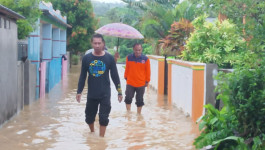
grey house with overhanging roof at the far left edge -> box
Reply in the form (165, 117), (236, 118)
(0, 4), (24, 125)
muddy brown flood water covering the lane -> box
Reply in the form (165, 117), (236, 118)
(0, 65), (198, 150)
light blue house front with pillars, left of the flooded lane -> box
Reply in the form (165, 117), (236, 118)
(28, 2), (69, 99)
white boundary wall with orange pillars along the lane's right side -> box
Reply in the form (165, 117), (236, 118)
(148, 55), (222, 122)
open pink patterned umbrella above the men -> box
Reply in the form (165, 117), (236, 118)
(95, 23), (144, 51)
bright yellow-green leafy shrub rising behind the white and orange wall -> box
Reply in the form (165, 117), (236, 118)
(183, 16), (246, 68)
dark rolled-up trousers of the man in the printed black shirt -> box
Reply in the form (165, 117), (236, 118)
(85, 96), (111, 126)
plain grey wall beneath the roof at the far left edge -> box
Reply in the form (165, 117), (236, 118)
(0, 15), (18, 124)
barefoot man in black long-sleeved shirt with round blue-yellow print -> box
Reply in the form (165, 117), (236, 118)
(76, 34), (122, 137)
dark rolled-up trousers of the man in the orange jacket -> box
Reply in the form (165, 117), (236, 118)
(124, 84), (145, 107)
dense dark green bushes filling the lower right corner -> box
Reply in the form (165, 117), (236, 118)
(194, 58), (265, 150)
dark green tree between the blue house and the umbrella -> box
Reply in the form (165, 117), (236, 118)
(50, 0), (97, 54)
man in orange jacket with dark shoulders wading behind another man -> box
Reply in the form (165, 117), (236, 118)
(124, 43), (150, 114)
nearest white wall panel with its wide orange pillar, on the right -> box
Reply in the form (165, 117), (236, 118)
(167, 59), (207, 122)
